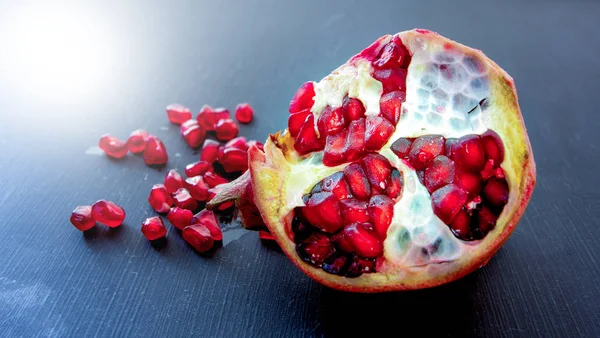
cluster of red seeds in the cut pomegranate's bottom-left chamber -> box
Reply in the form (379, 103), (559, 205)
(292, 154), (403, 277)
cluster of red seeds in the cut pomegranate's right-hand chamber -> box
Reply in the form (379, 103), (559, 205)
(392, 130), (509, 240)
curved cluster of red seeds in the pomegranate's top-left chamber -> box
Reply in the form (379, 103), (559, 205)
(288, 36), (410, 166)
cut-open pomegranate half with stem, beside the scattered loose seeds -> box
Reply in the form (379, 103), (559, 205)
(207, 30), (535, 292)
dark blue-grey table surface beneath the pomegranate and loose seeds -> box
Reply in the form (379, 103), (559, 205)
(0, 0), (600, 337)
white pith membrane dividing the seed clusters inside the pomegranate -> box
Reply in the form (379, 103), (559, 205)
(281, 35), (504, 273)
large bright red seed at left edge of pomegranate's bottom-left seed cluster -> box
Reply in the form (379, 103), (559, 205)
(303, 191), (343, 233)
